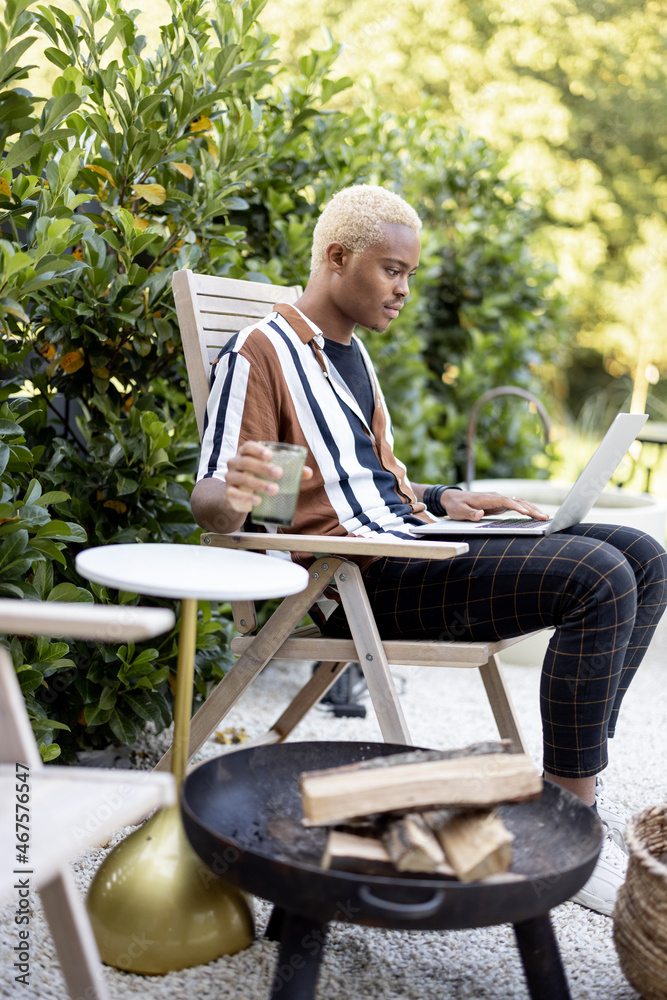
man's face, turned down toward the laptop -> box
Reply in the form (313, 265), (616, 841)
(335, 223), (421, 333)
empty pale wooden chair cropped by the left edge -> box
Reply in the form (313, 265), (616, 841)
(0, 599), (176, 1000)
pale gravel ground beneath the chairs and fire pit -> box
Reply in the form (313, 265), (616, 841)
(0, 624), (667, 1000)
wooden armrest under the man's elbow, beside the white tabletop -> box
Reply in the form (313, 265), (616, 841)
(201, 531), (468, 559)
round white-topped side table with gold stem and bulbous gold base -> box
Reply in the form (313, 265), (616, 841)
(76, 542), (308, 975)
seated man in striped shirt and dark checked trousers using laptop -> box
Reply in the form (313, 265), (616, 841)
(192, 185), (667, 914)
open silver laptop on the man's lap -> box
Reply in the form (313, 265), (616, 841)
(410, 413), (648, 537)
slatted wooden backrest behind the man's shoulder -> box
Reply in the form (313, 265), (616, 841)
(173, 270), (301, 437)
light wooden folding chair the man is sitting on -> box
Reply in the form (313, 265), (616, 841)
(158, 270), (548, 768)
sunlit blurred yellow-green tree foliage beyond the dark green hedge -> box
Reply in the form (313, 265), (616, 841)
(264, 0), (667, 422)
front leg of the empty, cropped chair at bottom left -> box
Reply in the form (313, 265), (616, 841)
(39, 868), (109, 1000)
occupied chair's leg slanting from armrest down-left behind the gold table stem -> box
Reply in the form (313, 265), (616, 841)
(155, 556), (342, 771)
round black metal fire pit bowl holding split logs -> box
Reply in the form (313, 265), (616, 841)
(181, 742), (602, 930)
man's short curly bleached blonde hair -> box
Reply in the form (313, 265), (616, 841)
(310, 184), (422, 277)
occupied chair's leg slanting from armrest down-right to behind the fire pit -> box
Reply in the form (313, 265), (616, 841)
(334, 562), (412, 746)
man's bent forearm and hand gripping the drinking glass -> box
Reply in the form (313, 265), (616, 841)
(190, 441), (313, 534)
